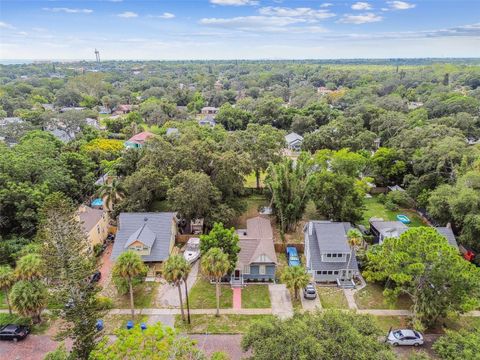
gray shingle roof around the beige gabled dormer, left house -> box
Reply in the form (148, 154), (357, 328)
(112, 212), (175, 262)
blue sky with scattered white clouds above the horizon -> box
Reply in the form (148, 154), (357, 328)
(0, 0), (480, 60)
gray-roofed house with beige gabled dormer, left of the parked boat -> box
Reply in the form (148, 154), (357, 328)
(112, 212), (177, 273)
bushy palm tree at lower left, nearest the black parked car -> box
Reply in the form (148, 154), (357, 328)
(10, 280), (48, 323)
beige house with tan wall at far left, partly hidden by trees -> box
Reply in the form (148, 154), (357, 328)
(77, 205), (109, 249)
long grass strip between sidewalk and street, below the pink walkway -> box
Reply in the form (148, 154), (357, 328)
(175, 312), (272, 334)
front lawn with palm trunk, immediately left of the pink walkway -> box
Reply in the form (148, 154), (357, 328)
(188, 277), (233, 309)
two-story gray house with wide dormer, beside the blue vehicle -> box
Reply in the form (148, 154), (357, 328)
(304, 221), (359, 287)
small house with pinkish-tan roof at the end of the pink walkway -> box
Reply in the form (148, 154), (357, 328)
(230, 216), (278, 286)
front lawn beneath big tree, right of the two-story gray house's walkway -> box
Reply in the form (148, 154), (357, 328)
(355, 283), (412, 310)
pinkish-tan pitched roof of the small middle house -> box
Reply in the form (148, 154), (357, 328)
(237, 216), (277, 268)
